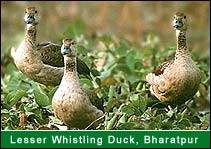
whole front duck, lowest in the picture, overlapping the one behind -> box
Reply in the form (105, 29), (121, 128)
(52, 38), (104, 129)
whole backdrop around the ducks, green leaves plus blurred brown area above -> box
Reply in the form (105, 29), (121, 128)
(1, 1), (210, 130)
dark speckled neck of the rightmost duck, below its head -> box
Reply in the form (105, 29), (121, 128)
(175, 30), (188, 59)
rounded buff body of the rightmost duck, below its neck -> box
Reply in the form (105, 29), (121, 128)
(147, 53), (200, 104)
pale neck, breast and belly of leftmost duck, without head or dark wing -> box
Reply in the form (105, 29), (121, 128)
(12, 22), (64, 86)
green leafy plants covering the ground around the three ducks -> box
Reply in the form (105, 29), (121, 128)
(1, 21), (210, 130)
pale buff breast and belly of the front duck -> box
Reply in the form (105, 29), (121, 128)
(52, 73), (103, 129)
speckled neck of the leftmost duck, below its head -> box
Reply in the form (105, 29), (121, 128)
(25, 24), (37, 47)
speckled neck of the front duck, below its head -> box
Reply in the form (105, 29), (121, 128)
(64, 56), (78, 79)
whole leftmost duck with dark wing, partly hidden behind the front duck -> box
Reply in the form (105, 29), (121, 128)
(11, 7), (90, 86)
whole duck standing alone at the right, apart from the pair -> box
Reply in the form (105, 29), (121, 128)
(146, 12), (201, 105)
